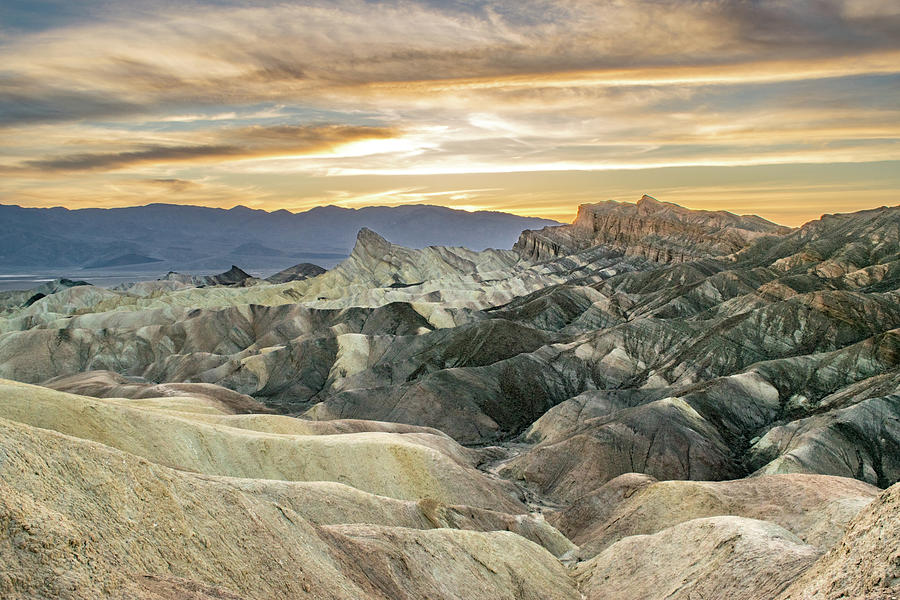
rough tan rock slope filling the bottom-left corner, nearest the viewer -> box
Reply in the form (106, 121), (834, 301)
(0, 419), (579, 600)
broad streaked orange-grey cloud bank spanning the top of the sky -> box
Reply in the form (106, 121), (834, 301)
(2, 0), (900, 119)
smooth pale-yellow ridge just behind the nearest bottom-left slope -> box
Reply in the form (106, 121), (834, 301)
(0, 382), (522, 512)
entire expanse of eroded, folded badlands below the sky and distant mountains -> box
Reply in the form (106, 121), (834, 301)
(0, 197), (900, 600)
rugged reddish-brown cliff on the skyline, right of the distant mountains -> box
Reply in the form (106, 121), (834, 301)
(514, 196), (791, 264)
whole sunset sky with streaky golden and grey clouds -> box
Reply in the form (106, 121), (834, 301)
(0, 0), (900, 226)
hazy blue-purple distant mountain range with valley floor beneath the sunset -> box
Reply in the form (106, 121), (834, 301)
(0, 204), (557, 272)
